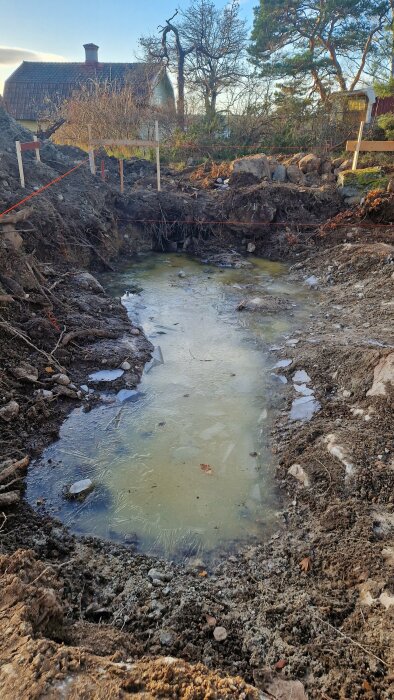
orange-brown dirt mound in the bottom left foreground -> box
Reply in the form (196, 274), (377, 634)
(0, 550), (261, 700)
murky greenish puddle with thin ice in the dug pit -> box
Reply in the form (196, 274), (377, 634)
(27, 255), (302, 558)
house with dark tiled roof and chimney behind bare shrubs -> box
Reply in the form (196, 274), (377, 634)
(4, 44), (175, 132)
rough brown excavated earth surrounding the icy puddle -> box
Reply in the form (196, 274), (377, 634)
(0, 106), (394, 700)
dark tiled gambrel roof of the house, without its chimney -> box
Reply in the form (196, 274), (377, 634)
(3, 61), (164, 120)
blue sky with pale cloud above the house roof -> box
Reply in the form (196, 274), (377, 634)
(0, 0), (258, 94)
